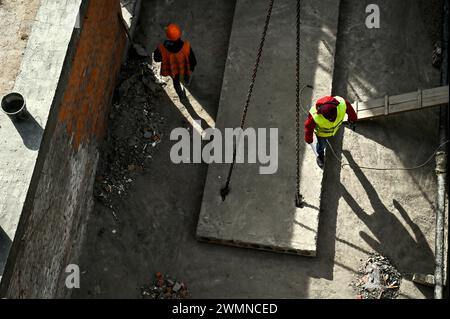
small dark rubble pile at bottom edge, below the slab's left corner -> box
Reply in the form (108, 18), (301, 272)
(141, 272), (189, 299)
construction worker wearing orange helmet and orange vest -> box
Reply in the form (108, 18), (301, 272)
(153, 23), (197, 99)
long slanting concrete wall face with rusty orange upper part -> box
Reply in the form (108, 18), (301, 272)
(0, 0), (126, 298)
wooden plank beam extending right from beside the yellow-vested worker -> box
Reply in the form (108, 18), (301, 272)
(355, 86), (449, 120)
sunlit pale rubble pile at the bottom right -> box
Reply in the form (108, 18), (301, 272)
(352, 255), (402, 299)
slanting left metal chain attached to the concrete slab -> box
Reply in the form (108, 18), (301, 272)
(220, 0), (275, 200)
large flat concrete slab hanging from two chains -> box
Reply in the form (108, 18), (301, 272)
(197, 0), (340, 256)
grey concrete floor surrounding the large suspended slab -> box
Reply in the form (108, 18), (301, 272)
(74, 0), (440, 298)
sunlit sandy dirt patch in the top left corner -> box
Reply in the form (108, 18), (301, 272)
(0, 0), (41, 97)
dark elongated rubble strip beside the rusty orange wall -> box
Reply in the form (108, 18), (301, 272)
(94, 59), (164, 208)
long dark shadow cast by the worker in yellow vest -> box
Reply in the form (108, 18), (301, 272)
(342, 151), (434, 284)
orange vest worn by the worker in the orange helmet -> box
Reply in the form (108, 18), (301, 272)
(158, 41), (191, 78)
